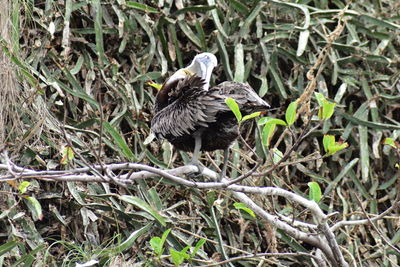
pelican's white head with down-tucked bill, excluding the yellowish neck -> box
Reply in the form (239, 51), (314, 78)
(184, 53), (218, 90)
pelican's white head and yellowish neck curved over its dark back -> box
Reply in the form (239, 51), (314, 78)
(165, 53), (218, 90)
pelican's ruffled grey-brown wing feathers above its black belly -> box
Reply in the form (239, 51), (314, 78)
(151, 81), (269, 139)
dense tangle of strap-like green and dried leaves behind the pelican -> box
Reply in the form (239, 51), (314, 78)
(0, 0), (400, 266)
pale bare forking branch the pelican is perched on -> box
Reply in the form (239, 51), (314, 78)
(0, 151), (348, 266)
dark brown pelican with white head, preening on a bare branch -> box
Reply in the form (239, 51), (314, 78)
(151, 53), (270, 178)
